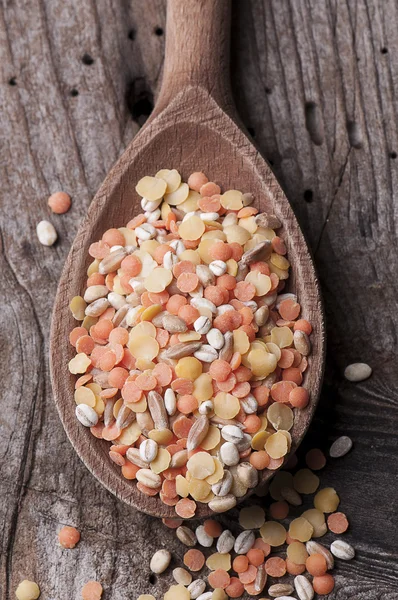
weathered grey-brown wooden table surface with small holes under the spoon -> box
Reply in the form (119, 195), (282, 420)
(0, 0), (398, 600)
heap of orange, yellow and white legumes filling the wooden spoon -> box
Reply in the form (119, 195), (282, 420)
(69, 169), (312, 518)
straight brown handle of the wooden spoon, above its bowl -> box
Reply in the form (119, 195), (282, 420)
(156, 0), (232, 112)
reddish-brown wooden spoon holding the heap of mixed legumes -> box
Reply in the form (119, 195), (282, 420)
(51, 0), (325, 517)
